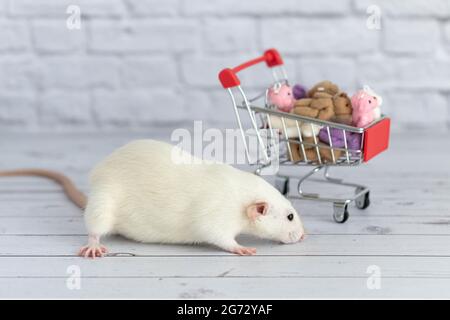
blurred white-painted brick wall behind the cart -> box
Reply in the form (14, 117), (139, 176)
(0, 0), (450, 132)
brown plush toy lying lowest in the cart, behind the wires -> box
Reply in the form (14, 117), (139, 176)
(290, 137), (342, 163)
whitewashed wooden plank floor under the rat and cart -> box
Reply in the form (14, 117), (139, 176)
(0, 134), (450, 299)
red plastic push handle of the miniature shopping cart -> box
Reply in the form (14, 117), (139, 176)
(219, 49), (283, 89)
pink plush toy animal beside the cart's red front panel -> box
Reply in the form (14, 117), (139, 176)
(351, 90), (379, 128)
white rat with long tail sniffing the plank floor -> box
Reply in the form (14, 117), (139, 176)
(0, 140), (304, 258)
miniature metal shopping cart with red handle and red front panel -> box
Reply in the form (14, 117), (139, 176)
(219, 49), (390, 223)
